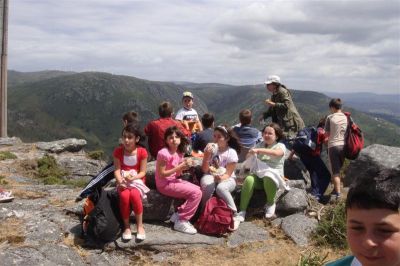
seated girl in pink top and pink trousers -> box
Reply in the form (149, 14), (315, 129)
(156, 126), (201, 234)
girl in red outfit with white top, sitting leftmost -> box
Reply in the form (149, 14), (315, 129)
(113, 124), (149, 241)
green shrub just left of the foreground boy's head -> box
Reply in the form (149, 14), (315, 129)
(312, 201), (347, 249)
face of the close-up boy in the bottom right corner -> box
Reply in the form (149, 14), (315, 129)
(346, 208), (400, 266)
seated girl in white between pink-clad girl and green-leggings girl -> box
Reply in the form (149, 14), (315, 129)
(200, 125), (241, 229)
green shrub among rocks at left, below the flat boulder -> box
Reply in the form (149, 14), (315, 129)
(37, 154), (68, 185)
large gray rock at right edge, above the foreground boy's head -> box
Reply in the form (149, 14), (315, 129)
(343, 144), (400, 186)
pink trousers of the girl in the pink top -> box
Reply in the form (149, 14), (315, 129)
(157, 179), (202, 221)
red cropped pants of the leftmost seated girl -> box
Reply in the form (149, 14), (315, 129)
(118, 188), (143, 219)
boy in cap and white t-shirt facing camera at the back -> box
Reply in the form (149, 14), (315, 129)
(175, 91), (203, 134)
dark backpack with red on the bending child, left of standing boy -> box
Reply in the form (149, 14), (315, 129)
(293, 127), (323, 156)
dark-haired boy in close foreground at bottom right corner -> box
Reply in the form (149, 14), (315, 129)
(327, 169), (400, 266)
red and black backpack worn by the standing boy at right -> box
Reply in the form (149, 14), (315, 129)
(344, 112), (364, 160)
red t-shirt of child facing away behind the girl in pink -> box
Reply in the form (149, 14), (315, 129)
(144, 117), (187, 158)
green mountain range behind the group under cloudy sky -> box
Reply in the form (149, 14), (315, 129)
(8, 71), (400, 154)
